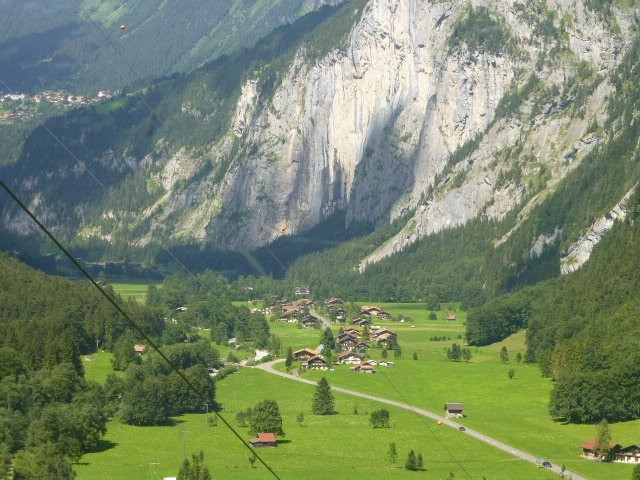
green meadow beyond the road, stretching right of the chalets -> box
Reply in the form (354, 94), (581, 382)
(286, 303), (640, 480)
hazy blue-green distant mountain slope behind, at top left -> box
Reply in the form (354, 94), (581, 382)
(0, 0), (339, 93)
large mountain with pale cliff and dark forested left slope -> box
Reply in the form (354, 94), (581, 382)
(2, 0), (637, 284)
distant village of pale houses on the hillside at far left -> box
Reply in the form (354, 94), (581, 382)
(0, 90), (115, 123)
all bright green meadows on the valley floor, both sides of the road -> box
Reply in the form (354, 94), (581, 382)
(76, 302), (640, 480)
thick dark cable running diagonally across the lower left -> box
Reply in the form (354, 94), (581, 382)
(0, 179), (282, 480)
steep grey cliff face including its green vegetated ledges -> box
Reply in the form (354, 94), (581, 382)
(5, 0), (634, 264)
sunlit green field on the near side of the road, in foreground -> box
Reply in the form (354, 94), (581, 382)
(75, 369), (554, 480)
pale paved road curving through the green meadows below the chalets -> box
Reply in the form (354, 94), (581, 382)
(255, 359), (587, 480)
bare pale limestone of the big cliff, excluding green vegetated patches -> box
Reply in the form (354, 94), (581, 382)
(178, 0), (628, 253)
